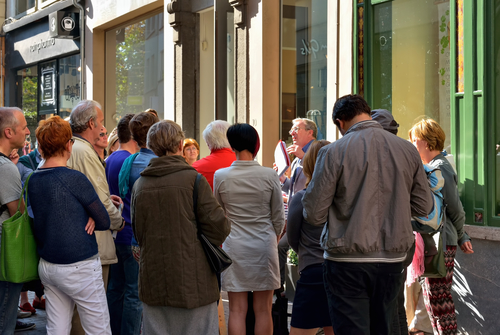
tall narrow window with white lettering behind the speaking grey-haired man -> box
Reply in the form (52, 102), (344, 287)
(281, 0), (327, 143)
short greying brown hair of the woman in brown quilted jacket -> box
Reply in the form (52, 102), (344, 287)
(147, 120), (184, 157)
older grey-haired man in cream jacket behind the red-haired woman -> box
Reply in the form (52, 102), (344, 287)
(68, 100), (124, 334)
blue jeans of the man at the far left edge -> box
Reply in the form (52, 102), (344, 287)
(0, 281), (23, 335)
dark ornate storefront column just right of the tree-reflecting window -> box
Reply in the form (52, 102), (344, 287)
(167, 0), (198, 138)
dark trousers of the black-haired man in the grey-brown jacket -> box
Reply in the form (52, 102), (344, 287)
(323, 260), (404, 335)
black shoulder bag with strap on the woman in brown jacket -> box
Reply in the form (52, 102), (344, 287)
(193, 173), (233, 273)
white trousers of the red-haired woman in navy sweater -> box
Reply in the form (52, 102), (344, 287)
(38, 257), (111, 335)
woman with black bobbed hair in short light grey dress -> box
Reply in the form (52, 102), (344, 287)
(214, 124), (285, 335)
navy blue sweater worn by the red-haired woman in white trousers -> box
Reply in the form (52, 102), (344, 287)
(28, 167), (110, 264)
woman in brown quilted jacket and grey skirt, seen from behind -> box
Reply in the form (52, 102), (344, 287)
(131, 120), (230, 334)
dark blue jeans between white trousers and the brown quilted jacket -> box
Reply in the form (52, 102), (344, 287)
(107, 244), (142, 335)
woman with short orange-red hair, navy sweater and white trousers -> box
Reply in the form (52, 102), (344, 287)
(27, 116), (111, 334)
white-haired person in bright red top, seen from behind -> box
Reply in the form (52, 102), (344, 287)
(192, 120), (236, 189)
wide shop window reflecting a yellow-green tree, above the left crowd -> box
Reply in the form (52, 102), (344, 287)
(105, 13), (164, 127)
